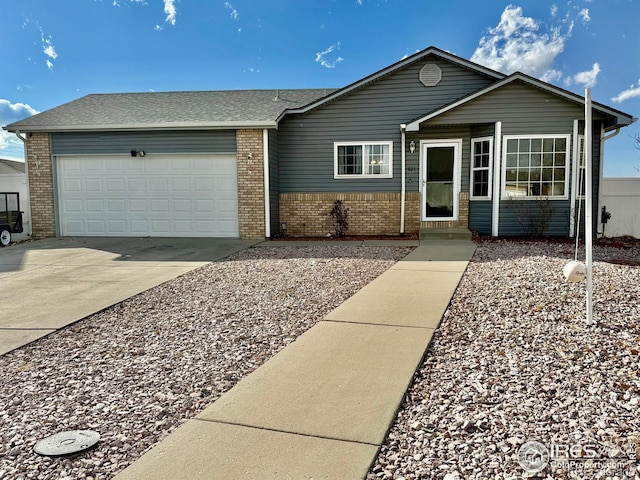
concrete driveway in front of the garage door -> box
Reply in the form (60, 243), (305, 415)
(0, 238), (259, 355)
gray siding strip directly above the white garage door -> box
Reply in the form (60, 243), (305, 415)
(51, 130), (236, 155)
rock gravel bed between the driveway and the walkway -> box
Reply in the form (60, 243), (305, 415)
(0, 245), (411, 480)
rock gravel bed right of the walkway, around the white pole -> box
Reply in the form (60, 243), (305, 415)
(367, 241), (640, 480)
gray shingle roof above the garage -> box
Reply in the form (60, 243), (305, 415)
(4, 89), (335, 132)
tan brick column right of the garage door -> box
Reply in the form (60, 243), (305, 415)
(236, 129), (266, 239)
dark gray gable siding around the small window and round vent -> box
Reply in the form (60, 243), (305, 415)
(279, 57), (492, 192)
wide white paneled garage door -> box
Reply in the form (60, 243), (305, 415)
(57, 155), (239, 237)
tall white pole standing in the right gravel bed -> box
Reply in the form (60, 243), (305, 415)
(584, 88), (593, 325)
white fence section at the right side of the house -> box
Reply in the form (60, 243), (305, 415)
(598, 178), (640, 238)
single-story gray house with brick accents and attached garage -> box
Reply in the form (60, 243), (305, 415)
(4, 47), (636, 238)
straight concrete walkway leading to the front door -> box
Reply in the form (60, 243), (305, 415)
(116, 241), (475, 480)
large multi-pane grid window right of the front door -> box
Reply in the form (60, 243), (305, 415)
(502, 135), (569, 199)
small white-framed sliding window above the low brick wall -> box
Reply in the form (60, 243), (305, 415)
(334, 142), (393, 178)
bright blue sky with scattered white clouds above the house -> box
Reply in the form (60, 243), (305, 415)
(0, 0), (640, 176)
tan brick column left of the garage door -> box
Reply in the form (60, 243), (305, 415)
(25, 133), (56, 238)
